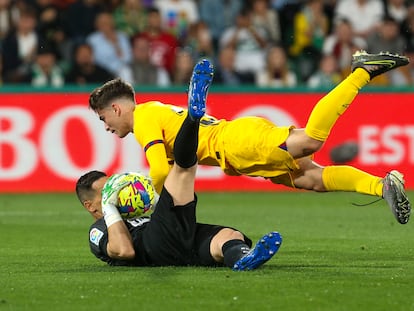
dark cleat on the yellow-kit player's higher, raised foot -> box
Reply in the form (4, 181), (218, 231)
(352, 50), (410, 80)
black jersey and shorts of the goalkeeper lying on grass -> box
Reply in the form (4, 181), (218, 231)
(89, 188), (251, 266)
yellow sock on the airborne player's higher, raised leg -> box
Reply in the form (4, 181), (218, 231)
(305, 68), (370, 141)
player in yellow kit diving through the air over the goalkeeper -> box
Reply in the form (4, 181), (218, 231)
(89, 51), (411, 224)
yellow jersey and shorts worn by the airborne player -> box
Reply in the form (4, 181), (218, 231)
(133, 101), (298, 193)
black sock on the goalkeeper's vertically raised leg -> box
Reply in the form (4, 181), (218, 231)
(174, 114), (200, 168)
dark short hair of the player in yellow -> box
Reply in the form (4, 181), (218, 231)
(89, 78), (135, 111)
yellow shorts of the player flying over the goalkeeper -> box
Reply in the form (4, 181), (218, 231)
(220, 117), (299, 186)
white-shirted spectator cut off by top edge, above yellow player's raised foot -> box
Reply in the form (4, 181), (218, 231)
(334, 0), (385, 38)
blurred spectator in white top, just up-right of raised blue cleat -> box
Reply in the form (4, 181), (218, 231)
(220, 8), (268, 80)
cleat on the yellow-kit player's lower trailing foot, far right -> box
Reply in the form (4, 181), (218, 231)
(382, 170), (411, 224)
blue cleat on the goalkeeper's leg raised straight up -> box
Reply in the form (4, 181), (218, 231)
(188, 59), (214, 120)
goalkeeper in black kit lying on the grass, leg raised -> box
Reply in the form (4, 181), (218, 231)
(76, 63), (282, 271)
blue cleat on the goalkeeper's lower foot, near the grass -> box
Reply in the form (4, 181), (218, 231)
(233, 232), (282, 271)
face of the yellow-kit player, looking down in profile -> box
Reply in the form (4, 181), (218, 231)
(97, 104), (130, 138)
